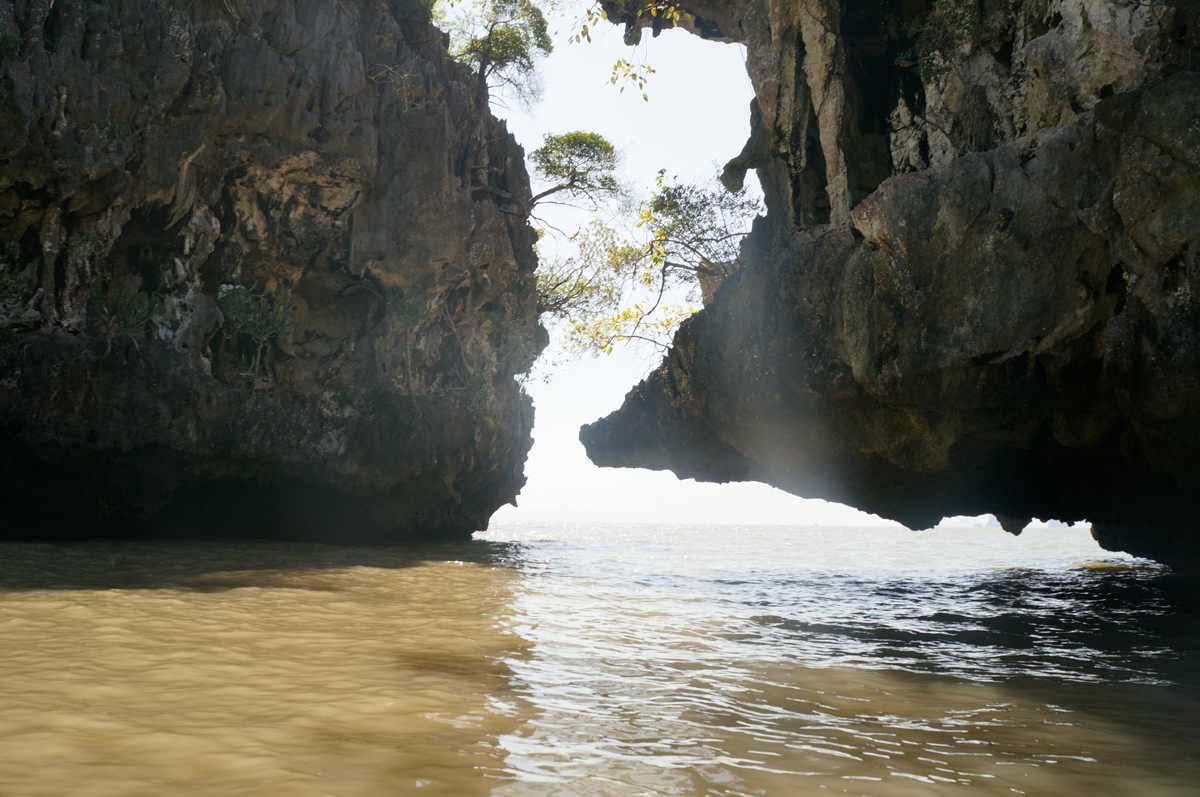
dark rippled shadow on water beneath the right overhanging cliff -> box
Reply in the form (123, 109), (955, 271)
(754, 567), (1200, 683)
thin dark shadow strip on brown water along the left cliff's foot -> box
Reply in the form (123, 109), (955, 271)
(0, 540), (523, 592)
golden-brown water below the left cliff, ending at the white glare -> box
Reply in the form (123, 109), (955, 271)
(0, 545), (527, 797)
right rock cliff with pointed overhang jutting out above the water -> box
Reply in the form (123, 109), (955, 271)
(581, 0), (1200, 570)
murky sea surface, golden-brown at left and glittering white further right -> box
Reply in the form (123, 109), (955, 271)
(0, 523), (1200, 797)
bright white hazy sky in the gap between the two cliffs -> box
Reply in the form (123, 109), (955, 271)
(484, 23), (1022, 526)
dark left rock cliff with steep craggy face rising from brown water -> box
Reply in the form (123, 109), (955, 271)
(0, 0), (544, 541)
